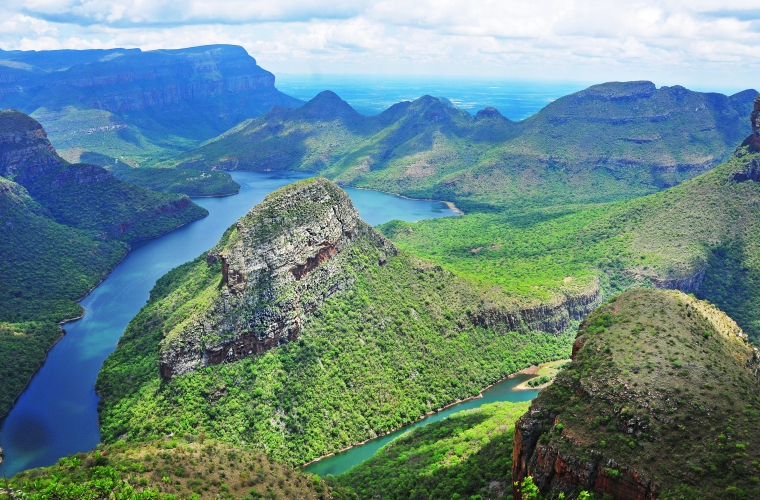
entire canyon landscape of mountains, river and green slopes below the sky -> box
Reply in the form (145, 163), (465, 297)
(0, 45), (760, 500)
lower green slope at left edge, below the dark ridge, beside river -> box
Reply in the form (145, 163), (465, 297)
(0, 177), (128, 416)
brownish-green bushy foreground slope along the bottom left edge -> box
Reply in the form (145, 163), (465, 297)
(0, 435), (354, 500)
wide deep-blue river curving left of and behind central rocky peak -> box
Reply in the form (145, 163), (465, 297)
(0, 172), (455, 477)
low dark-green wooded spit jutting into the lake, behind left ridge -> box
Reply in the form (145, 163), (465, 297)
(110, 164), (240, 197)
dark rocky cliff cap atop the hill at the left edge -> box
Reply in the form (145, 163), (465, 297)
(0, 109), (61, 184)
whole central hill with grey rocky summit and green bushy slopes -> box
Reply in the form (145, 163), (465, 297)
(96, 179), (576, 464)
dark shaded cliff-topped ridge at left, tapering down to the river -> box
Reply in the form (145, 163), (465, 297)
(0, 110), (207, 241)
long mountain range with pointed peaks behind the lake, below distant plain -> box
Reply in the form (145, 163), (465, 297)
(163, 82), (757, 212)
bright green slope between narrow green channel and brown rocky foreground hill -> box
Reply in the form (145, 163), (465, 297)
(332, 402), (529, 500)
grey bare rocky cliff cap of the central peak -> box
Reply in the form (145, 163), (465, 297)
(161, 179), (396, 378)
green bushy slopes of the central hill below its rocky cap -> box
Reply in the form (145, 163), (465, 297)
(96, 240), (570, 464)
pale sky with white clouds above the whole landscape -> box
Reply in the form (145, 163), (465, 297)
(0, 0), (760, 90)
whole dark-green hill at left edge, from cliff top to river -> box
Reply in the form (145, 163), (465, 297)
(0, 110), (207, 415)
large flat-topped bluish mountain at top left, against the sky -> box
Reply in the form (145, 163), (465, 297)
(0, 45), (302, 165)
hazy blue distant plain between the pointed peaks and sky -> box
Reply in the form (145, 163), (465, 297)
(277, 74), (598, 121)
